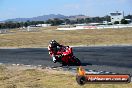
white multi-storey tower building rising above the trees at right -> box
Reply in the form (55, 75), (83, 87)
(110, 11), (124, 24)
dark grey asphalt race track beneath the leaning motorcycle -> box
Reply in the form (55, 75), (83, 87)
(0, 46), (132, 75)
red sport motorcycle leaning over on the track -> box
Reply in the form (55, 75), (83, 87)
(51, 46), (81, 66)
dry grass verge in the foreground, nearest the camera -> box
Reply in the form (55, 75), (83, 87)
(0, 65), (132, 88)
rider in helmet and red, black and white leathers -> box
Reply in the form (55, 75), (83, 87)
(48, 40), (63, 63)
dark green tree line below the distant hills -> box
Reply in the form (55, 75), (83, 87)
(0, 15), (132, 29)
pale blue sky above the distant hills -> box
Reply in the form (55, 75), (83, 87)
(0, 0), (132, 21)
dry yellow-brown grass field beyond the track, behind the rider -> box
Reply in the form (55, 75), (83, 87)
(0, 28), (132, 48)
